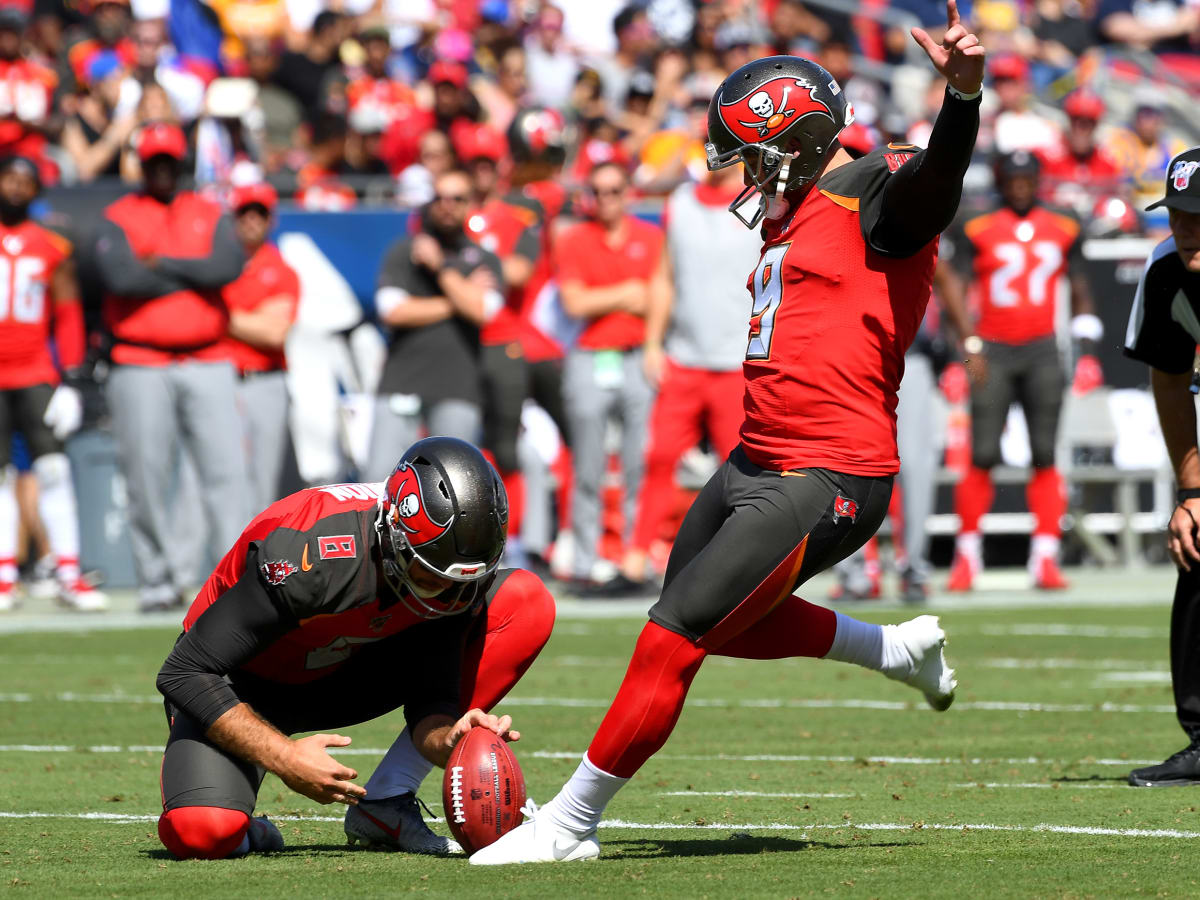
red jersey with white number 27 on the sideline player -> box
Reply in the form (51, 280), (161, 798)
(955, 206), (1082, 343)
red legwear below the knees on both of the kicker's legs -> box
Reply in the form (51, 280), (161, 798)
(588, 595), (838, 778)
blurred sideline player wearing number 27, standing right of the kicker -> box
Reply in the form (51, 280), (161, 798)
(938, 150), (1104, 590)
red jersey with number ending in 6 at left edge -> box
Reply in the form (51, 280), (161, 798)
(0, 221), (71, 390)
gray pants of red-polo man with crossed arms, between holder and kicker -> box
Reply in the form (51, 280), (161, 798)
(563, 348), (654, 578)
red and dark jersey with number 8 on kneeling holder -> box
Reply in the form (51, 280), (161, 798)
(184, 482), (436, 684)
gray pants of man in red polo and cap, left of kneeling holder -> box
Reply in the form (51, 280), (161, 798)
(236, 371), (288, 515)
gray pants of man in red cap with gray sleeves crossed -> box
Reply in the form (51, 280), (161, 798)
(107, 362), (251, 602)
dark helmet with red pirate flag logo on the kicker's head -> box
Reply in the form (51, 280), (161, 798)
(704, 56), (854, 228)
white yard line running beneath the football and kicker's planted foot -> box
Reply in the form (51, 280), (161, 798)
(0, 810), (1200, 840)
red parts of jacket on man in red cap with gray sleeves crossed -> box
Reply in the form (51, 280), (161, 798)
(103, 191), (229, 366)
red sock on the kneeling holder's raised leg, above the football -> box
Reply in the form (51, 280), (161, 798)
(460, 569), (554, 710)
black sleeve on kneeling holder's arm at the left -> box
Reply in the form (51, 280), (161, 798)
(156, 552), (298, 731)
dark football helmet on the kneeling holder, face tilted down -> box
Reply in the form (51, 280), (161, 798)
(376, 437), (509, 619)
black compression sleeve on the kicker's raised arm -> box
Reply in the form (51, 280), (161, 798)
(871, 90), (979, 257)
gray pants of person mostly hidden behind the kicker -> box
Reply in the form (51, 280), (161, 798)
(835, 353), (941, 590)
